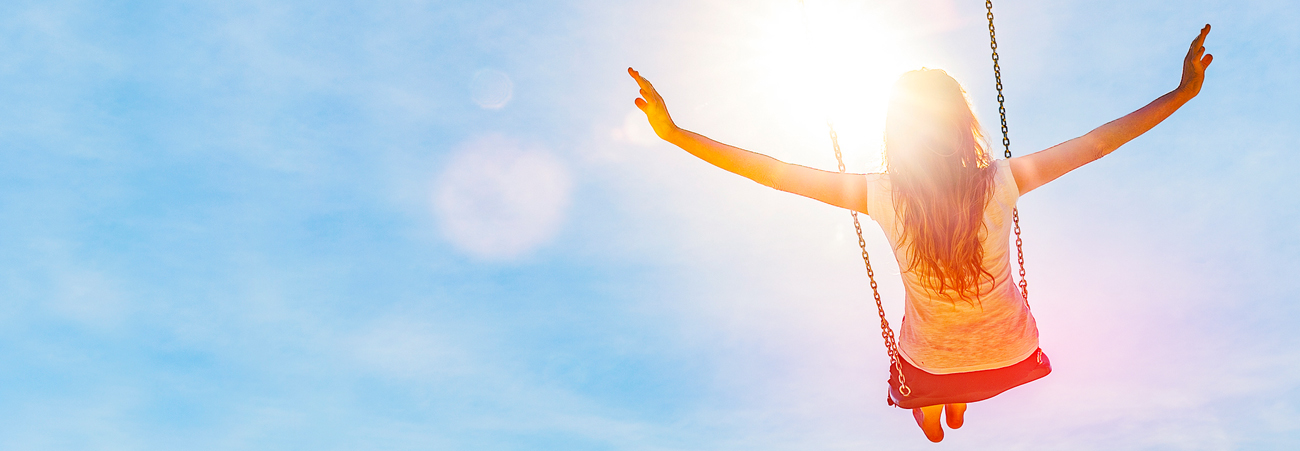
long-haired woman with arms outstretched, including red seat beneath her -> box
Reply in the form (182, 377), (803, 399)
(628, 25), (1213, 442)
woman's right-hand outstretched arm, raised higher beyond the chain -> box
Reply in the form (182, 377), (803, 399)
(1010, 25), (1214, 195)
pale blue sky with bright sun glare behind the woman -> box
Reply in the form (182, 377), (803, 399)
(0, 0), (1300, 451)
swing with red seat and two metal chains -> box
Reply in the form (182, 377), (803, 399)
(800, 0), (1052, 409)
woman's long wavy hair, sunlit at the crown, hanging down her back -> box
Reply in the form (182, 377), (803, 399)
(885, 69), (993, 302)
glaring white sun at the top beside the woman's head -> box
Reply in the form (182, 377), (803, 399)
(757, 0), (919, 170)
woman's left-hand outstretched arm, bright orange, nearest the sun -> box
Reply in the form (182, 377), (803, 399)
(628, 68), (867, 213)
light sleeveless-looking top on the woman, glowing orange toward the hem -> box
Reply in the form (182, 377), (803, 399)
(866, 160), (1039, 374)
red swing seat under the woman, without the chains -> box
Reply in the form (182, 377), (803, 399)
(889, 348), (1052, 408)
